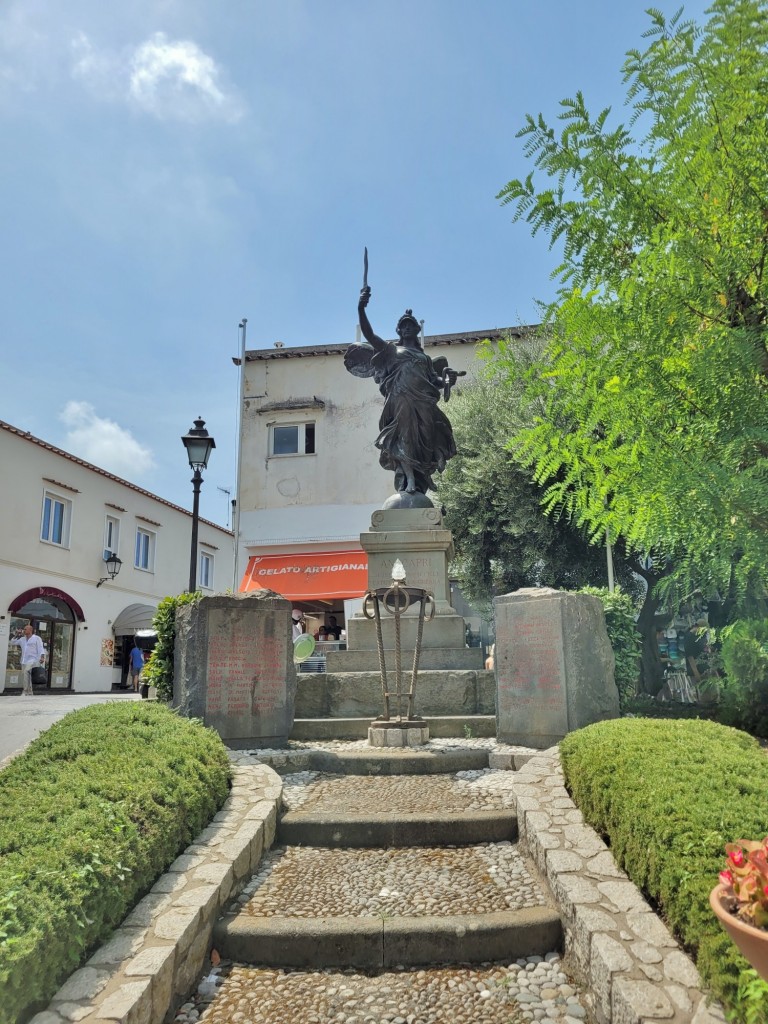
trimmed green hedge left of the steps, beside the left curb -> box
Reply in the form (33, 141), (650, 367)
(0, 701), (229, 1024)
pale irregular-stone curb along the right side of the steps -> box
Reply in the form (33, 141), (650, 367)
(505, 746), (725, 1024)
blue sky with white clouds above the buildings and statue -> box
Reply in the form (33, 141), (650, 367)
(0, 0), (706, 524)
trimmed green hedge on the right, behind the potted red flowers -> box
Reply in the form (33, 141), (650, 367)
(560, 719), (768, 1021)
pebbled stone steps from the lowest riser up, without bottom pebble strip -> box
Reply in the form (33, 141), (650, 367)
(213, 750), (562, 983)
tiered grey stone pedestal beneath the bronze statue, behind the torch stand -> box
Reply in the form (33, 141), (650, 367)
(335, 508), (482, 671)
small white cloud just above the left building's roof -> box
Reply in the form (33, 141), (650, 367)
(58, 401), (155, 482)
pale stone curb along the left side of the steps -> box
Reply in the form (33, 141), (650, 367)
(31, 755), (283, 1024)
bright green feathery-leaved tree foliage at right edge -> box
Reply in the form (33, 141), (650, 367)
(498, 0), (768, 598)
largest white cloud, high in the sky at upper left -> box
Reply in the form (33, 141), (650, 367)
(72, 32), (243, 121)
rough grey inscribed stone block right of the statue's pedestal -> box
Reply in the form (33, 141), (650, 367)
(494, 587), (618, 749)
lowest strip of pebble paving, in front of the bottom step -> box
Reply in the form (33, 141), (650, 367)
(175, 952), (586, 1024)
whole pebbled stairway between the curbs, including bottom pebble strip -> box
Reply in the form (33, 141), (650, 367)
(191, 770), (584, 1024)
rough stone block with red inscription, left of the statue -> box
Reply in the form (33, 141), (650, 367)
(173, 591), (296, 748)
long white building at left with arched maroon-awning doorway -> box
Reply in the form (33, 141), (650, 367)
(0, 420), (234, 693)
